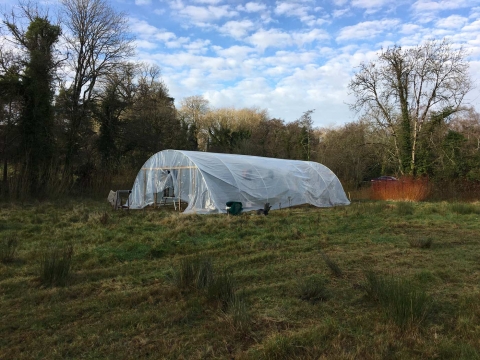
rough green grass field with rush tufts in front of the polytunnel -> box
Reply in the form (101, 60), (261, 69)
(0, 201), (480, 360)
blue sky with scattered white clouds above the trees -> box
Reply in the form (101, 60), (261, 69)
(3, 0), (480, 126)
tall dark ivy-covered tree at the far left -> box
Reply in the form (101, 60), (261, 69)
(5, 8), (61, 195)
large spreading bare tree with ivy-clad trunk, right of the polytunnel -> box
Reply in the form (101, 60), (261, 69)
(349, 40), (472, 175)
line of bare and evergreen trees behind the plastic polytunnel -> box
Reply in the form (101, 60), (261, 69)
(0, 0), (480, 197)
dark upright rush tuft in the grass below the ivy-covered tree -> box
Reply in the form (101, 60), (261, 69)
(40, 245), (73, 286)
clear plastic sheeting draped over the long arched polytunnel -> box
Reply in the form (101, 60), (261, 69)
(130, 150), (350, 214)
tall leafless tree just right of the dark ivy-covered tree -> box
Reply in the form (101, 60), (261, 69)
(62, 0), (134, 174)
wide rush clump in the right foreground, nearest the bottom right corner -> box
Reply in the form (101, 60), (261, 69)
(365, 271), (431, 330)
